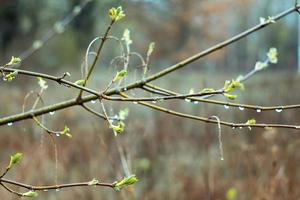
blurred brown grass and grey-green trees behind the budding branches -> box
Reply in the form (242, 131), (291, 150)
(0, 0), (300, 200)
